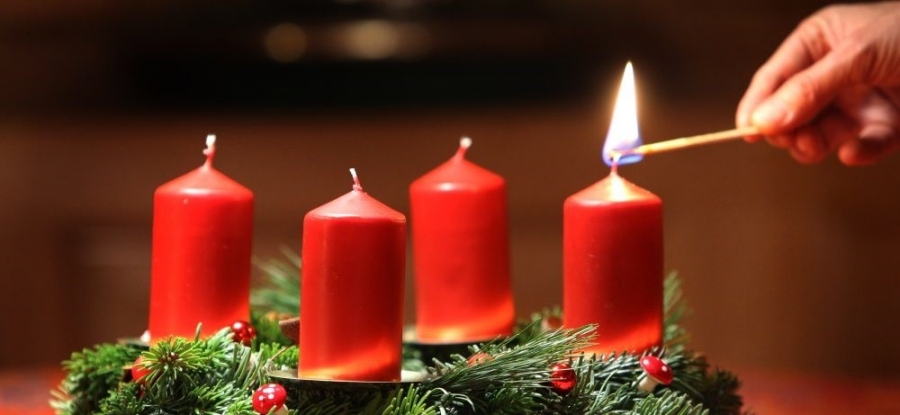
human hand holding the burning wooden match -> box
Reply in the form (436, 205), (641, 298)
(736, 2), (900, 165)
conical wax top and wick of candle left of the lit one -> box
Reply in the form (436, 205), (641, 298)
(412, 137), (504, 191)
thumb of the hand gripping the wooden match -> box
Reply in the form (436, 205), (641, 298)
(751, 48), (858, 134)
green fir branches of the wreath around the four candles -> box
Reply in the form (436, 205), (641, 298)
(53, 272), (742, 415)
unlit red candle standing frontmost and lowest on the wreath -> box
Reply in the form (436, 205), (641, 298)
(298, 169), (406, 381)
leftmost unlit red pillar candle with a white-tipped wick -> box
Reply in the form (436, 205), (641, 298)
(149, 135), (253, 340)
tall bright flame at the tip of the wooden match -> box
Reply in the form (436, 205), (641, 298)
(603, 62), (644, 166)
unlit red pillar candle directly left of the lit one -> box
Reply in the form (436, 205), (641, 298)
(409, 138), (515, 342)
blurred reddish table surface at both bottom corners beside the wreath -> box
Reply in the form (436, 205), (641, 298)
(7, 368), (900, 415)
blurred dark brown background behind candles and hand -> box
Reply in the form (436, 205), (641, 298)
(0, 0), (900, 377)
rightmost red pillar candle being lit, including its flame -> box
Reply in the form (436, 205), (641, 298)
(563, 63), (663, 354)
